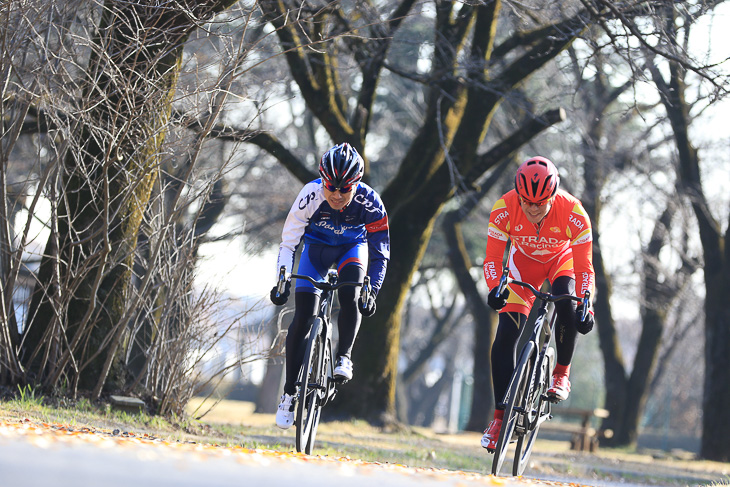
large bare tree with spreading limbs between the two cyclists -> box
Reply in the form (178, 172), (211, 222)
(239, 0), (589, 421)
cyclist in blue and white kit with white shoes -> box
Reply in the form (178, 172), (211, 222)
(270, 143), (390, 429)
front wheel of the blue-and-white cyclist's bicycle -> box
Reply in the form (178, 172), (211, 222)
(295, 318), (322, 454)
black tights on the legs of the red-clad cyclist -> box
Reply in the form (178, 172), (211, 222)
(492, 276), (578, 409)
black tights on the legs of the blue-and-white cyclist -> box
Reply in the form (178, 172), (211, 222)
(284, 265), (365, 395)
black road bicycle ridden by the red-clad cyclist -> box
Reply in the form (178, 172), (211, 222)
(492, 268), (590, 476)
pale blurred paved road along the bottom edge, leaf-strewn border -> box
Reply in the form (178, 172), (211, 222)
(0, 420), (576, 487)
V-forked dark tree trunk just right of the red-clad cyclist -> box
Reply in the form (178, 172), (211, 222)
(576, 59), (673, 446)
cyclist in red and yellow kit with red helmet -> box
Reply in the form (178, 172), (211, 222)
(481, 157), (595, 450)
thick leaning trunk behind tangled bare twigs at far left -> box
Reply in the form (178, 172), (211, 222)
(24, 0), (232, 396)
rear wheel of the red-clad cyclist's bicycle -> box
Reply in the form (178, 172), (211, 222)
(512, 347), (555, 476)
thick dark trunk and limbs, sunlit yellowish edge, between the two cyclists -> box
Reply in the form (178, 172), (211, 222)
(253, 0), (589, 421)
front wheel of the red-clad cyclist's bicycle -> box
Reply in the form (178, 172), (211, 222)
(492, 342), (535, 475)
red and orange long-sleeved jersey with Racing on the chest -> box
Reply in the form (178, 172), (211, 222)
(484, 190), (595, 296)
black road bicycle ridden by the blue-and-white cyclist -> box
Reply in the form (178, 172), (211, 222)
(277, 267), (371, 455)
